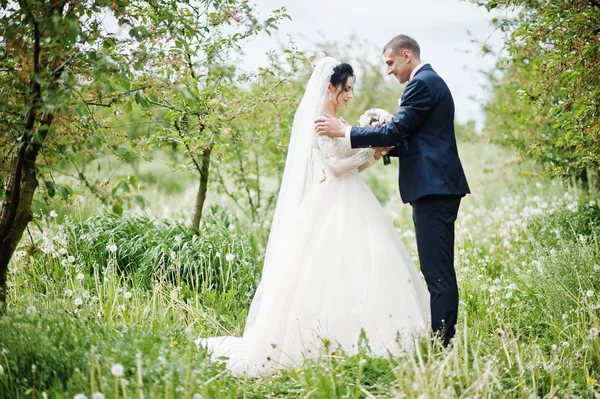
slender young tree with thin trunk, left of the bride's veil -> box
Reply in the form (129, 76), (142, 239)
(131, 0), (289, 229)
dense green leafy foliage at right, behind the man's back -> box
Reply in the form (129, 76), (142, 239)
(474, 0), (600, 179)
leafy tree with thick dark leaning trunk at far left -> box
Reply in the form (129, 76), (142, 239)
(0, 0), (141, 303)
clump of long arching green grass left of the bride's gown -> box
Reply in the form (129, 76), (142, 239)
(65, 207), (262, 298)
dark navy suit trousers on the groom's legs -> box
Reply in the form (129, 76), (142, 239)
(411, 195), (461, 346)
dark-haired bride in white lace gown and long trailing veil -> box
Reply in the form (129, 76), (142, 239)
(198, 57), (430, 376)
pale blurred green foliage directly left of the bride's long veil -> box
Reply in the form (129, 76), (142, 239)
(215, 46), (312, 226)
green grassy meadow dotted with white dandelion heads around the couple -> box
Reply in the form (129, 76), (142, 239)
(0, 143), (600, 399)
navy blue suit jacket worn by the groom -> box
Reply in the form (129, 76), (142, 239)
(350, 64), (470, 203)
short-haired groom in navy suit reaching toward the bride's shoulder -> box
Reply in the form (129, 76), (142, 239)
(316, 35), (469, 346)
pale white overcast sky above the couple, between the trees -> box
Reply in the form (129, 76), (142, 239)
(239, 0), (503, 126)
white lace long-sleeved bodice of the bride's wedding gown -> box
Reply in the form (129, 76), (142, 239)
(315, 135), (375, 177)
